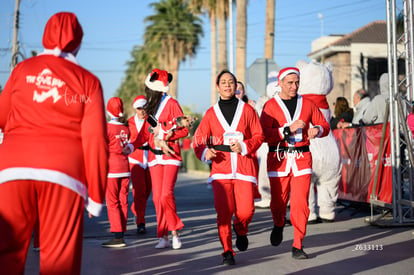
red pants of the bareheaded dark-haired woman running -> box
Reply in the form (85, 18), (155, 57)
(212, 180), (254, 254)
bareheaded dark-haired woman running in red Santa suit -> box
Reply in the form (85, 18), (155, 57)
(193, 71), (264, 265)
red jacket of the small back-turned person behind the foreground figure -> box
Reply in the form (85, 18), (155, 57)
(107, 120), (130, 178)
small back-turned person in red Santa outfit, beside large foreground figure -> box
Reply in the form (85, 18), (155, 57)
(102, 97), (130, 247)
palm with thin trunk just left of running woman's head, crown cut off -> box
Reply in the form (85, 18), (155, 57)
(189, 0), (218, 105)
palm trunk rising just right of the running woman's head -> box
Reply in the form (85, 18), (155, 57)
(236, 0), (247, 84)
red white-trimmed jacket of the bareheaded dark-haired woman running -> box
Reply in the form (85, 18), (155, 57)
(193, 100), (264, 184)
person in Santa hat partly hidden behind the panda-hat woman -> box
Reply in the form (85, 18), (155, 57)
(128, 95), (151, 234)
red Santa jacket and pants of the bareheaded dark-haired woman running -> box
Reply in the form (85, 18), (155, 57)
(193, 99), (264, 254)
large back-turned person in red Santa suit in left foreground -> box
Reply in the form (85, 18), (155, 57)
(0, 12), (108, 274)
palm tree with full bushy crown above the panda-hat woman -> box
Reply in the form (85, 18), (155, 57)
(144, 0), (203, 98)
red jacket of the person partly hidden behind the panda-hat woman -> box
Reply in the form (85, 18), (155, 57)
(128, 115), (149, 169)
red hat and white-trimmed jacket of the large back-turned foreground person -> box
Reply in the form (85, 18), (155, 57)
(0, 16), (108, 216)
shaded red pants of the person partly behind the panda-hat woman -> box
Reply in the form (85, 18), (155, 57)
(129, 163), (152, 225)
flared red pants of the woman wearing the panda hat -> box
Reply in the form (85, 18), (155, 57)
(150, 164), (184, 238)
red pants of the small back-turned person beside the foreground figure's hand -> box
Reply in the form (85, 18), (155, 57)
(105, 178), (129, 232)
